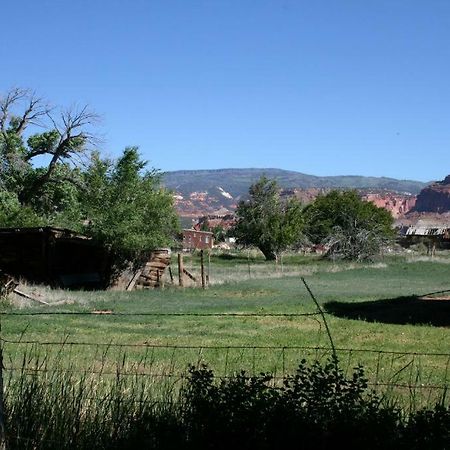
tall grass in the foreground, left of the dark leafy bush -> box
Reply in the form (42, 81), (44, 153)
(5, 355), (180, 450)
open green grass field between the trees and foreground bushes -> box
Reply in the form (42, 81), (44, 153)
(2, 254), (450, 410)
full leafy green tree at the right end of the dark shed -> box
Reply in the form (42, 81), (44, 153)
(81, 147), (179, 263)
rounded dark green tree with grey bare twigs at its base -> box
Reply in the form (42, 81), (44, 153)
(304, 191), (394, 260)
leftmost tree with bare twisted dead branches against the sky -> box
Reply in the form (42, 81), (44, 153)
(0, 88), (98, 220)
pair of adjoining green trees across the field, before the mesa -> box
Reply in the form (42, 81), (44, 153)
(234, 177), (394, 261)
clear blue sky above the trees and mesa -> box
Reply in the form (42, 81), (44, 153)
(0, 0), (450, 181)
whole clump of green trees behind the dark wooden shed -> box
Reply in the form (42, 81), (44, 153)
(0, 88), (178, 259)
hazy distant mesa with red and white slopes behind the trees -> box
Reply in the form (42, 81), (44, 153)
(163, 169), (428, 220)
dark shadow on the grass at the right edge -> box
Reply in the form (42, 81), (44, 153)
(324, 296), (450, 327)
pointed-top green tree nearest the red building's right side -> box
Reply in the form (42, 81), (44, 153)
(234, 176), (303, 260)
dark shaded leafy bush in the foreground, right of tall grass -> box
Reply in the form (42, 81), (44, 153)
(183, 360), (400, 449)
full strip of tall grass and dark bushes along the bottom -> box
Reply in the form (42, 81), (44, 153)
(6, 361), (450, 450)
